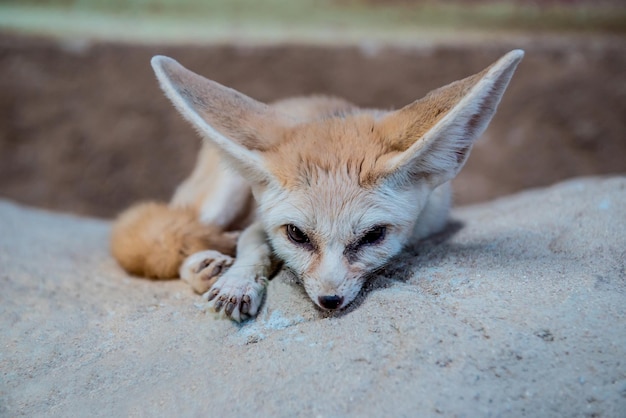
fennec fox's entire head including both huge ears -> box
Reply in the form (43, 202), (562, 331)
(152, 50), (523, 309)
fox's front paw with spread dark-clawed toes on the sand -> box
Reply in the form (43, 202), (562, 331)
(203, 265), (268, 322)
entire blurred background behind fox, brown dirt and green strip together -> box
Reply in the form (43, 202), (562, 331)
(0, 0), (626, 217)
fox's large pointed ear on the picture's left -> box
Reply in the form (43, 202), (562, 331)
(151, 55), (291, 182)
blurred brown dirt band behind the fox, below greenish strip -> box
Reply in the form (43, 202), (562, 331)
(0, 33), (626, 217)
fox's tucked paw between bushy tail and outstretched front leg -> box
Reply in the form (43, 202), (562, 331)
(180, 250), (235, 294)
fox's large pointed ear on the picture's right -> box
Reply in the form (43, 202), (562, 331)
(380, 50), (524, 187)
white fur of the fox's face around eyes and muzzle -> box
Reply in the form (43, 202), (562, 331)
(259, 168), (426, 308)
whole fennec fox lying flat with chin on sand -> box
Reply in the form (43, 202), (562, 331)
(111, 50), (523, 321)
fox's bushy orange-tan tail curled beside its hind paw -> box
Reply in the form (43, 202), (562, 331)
(111, 202), (237, 279)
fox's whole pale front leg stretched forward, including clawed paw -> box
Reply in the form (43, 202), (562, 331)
(203, 222), (280, 322)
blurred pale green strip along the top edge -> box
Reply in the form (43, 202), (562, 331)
(0, 0), (626, 41)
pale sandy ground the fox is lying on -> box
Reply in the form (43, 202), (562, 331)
(0, 176), (626, 417)
